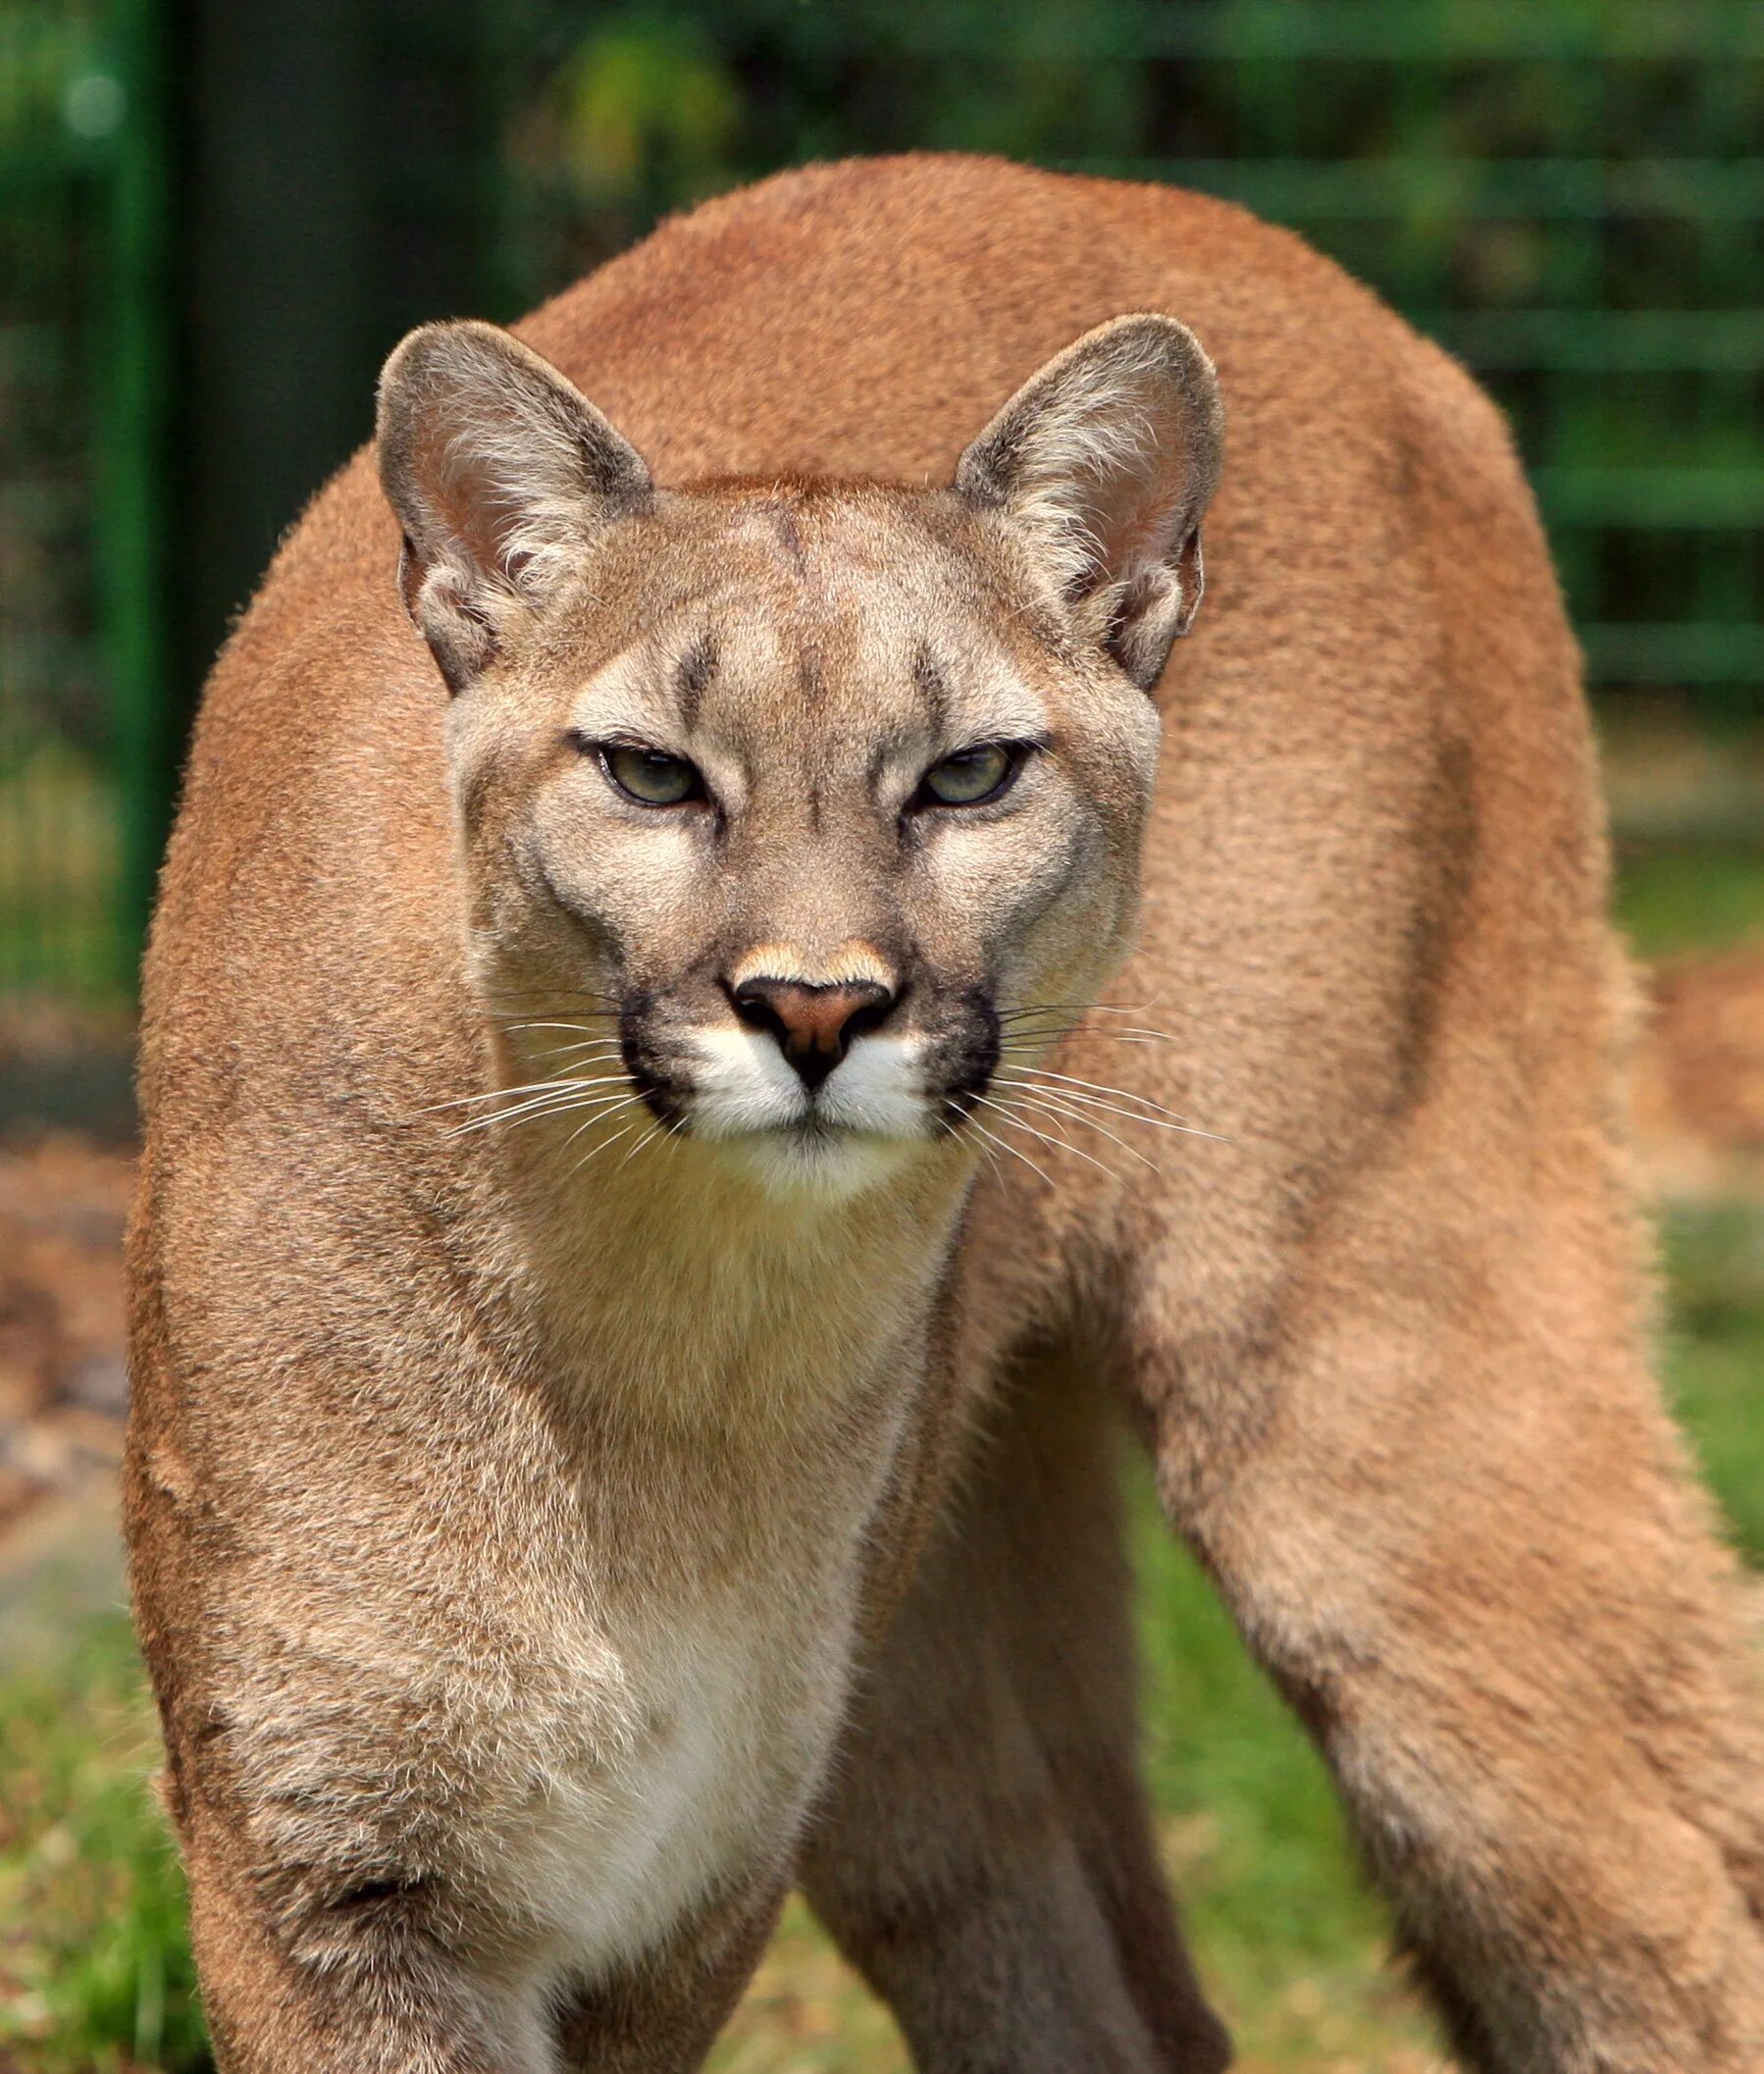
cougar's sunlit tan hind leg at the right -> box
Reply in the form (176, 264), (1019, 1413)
(1134, 1184), (1764, 2074)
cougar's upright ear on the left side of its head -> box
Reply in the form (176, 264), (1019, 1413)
(375, 324), (653, 691)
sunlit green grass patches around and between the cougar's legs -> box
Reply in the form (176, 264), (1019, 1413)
(0, 844), (1764, 2074)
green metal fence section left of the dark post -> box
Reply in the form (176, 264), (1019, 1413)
(0, 0), (170, 994)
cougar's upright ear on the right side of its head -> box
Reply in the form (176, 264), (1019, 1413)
(956, 315), (1225, 691)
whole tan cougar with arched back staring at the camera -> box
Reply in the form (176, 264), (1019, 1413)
(127, 158), (1764, 2074)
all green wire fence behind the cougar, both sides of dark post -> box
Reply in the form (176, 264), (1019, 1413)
(0, 0), (1764, 991)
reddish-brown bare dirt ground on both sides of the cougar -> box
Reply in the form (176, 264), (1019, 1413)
(0, 946), (1764, 1541)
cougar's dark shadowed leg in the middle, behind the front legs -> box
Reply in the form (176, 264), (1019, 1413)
(803, 1359), (1231, 2074)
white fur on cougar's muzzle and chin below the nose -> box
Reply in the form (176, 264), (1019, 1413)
(686, 1029), (933, 1195)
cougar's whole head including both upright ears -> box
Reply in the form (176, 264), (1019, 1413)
(380, 315), (1220, 1190)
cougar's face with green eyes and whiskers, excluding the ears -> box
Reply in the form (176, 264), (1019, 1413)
(454, 490), (1157, 1190)
